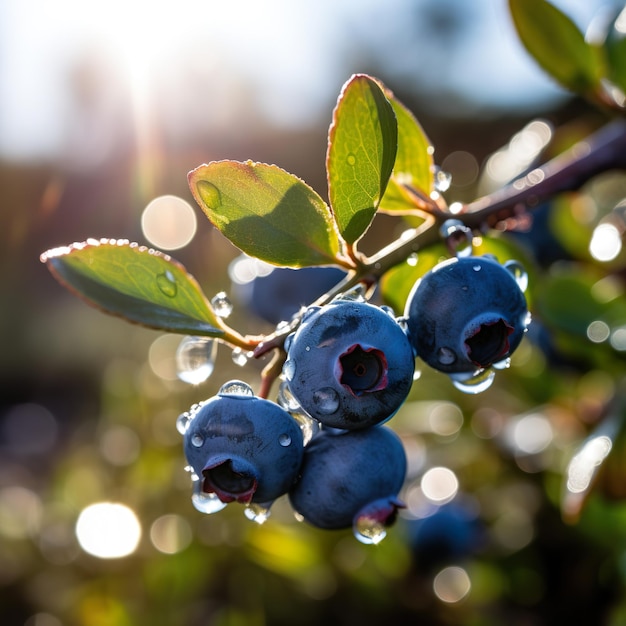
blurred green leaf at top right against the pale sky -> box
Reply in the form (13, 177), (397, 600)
(509, 0), (601, 95)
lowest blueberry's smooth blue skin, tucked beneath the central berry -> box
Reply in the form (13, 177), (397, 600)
(289, 426), (406, 529)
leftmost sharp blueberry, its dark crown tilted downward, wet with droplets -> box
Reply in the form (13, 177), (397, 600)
(184, 395), (303, 503)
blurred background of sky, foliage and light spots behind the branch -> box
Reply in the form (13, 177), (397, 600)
(0, 0), (626, 626)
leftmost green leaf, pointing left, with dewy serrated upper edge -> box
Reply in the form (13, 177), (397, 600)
(41, 239), (225, 337)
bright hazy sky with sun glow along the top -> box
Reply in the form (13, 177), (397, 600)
(0, 0), (611, 159)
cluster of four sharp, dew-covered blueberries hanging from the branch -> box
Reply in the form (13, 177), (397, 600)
(179, 256), (529, 543)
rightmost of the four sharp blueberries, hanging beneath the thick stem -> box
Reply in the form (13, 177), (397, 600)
(405, 256), (528, 373)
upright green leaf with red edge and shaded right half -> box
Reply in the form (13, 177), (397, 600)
(326, 74), (398, 244)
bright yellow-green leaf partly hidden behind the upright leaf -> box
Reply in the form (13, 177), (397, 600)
(379, 90), (434, 213)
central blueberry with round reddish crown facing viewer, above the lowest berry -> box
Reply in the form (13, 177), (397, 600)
(283, 300), (415, 430)
